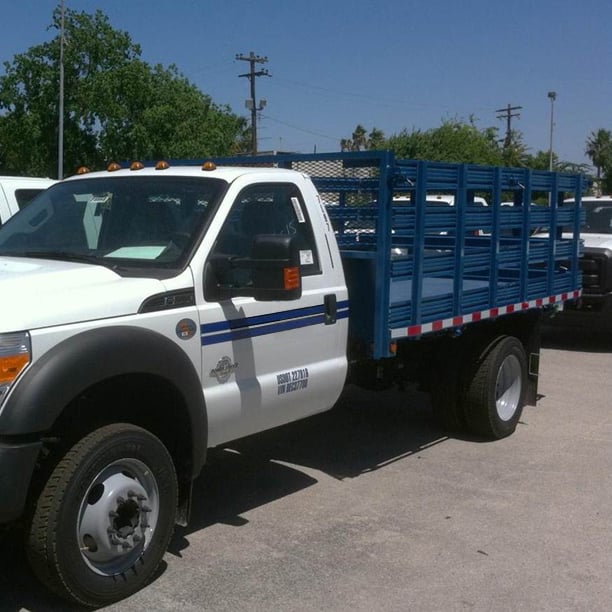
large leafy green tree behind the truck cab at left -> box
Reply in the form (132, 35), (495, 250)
(0, 9), (247, 176)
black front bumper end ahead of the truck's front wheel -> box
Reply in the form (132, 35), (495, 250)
(0, 441), (42, 524)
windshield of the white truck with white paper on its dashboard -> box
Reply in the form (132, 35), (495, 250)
(0, 175), (227, 277)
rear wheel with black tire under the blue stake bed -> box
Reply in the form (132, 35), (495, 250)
(462, 336), (527, 440)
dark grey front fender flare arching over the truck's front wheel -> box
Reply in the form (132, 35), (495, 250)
(0, 326), (208, 475)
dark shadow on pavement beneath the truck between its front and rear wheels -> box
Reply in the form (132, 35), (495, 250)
(172, 388), (447, 553)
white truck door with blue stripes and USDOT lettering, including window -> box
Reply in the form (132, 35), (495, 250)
(199, 182), (348, 445)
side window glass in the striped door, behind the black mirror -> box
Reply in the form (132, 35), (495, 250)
(207, 183), (321, 299)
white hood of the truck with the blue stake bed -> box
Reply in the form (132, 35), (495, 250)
(0, 257), (164, 333)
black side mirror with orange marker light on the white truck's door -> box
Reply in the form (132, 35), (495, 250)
(204, 234), (302, 302)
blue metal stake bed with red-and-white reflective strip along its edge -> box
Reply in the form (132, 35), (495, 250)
(208, 151), (587, 358)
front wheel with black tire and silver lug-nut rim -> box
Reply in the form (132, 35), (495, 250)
(26, 423), (178, 607)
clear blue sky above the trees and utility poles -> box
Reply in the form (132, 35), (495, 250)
(0, 0), (612, 163)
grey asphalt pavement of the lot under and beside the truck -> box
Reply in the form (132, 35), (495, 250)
(0, 330), (612, 612)
